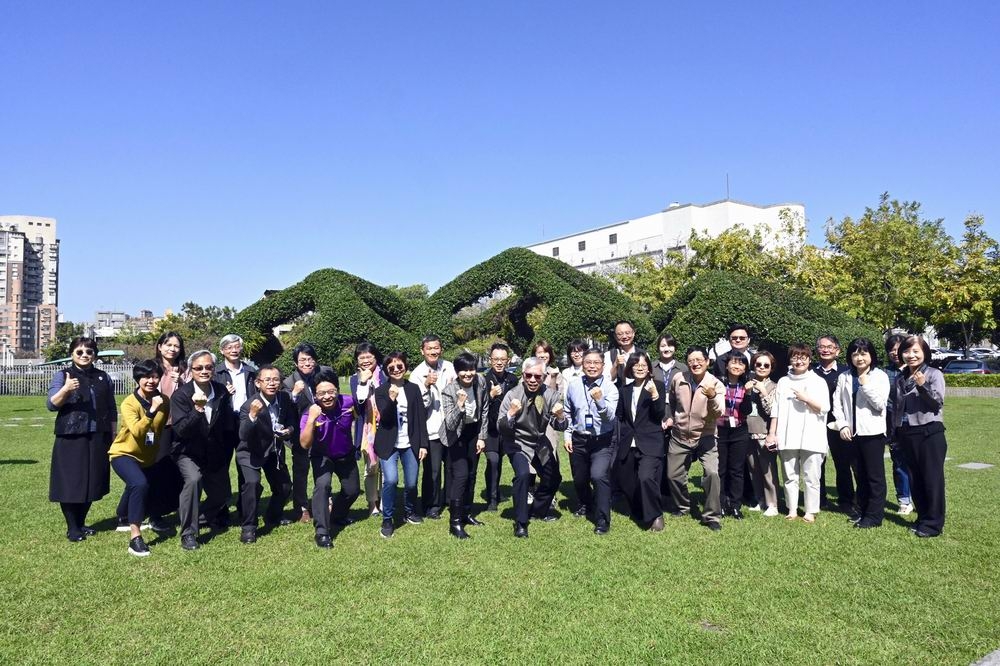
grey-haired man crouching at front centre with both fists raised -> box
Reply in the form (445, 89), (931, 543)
(497, 356), (569, 538)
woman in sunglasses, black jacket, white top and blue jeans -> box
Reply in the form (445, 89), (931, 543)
(368, 352), (430, 539)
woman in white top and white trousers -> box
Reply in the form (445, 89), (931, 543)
(764, 343), (830, 523)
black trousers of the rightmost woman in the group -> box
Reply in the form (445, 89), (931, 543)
(896, 421), (948, 534)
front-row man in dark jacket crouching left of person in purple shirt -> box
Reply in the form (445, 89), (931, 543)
(236, 365), (299, 543)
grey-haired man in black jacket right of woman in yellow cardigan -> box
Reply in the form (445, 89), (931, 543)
(170, 349), (236, 550)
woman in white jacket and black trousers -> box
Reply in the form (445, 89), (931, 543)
(833, 338), (889, 529)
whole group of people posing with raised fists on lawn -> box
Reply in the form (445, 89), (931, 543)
(48, 321), (947, 556)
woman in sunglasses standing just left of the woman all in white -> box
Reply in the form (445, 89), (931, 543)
(745, 351), (778, 518)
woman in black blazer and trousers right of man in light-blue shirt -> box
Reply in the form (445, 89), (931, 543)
(618, 352), (667, 532)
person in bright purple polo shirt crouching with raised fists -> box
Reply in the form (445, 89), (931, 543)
(299, 369), (361, 548)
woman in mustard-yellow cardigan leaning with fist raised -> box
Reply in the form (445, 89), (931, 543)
(108, 360), (169, 557)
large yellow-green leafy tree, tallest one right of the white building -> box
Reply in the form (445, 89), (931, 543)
(815, 193), (954, 331)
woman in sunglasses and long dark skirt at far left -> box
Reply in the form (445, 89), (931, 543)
(46, 337), (118, 542)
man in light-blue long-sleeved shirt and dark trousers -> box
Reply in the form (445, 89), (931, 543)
(563, 349), (618, 535)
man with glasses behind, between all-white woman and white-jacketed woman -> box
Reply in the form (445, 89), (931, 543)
(812, 334), (858, 510)
